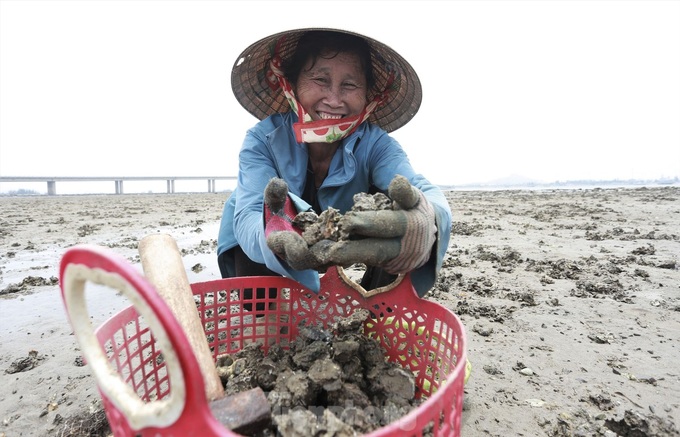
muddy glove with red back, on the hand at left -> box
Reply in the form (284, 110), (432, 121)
(264, 178), (321, 270)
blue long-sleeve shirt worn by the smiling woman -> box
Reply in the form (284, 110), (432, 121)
(217, 113), (451, 296)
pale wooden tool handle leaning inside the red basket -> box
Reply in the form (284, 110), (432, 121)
(138, 234), (224, 401)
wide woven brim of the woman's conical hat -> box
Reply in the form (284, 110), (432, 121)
(231, 28), (423, 132)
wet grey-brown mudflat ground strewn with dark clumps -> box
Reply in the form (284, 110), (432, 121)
(0, 187), (680, 437)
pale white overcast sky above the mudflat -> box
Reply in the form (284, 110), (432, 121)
(0, 0), (680, 191)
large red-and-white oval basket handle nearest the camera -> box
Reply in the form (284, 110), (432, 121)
(59, 245), (208, 430)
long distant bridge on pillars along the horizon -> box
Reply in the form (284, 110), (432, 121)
(0, 176), (236, 196)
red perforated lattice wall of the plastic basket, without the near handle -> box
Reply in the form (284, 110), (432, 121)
(96, 269), (466, 436)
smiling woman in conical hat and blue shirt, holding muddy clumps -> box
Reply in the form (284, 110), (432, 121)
(218, 29), (451, 296)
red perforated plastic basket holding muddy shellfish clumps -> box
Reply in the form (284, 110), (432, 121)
(60, 246), (466, 436)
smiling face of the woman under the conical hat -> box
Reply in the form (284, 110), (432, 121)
(294, 52), (368, 120)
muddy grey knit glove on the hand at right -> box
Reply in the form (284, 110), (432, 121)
(323, 176), (437, 274)
